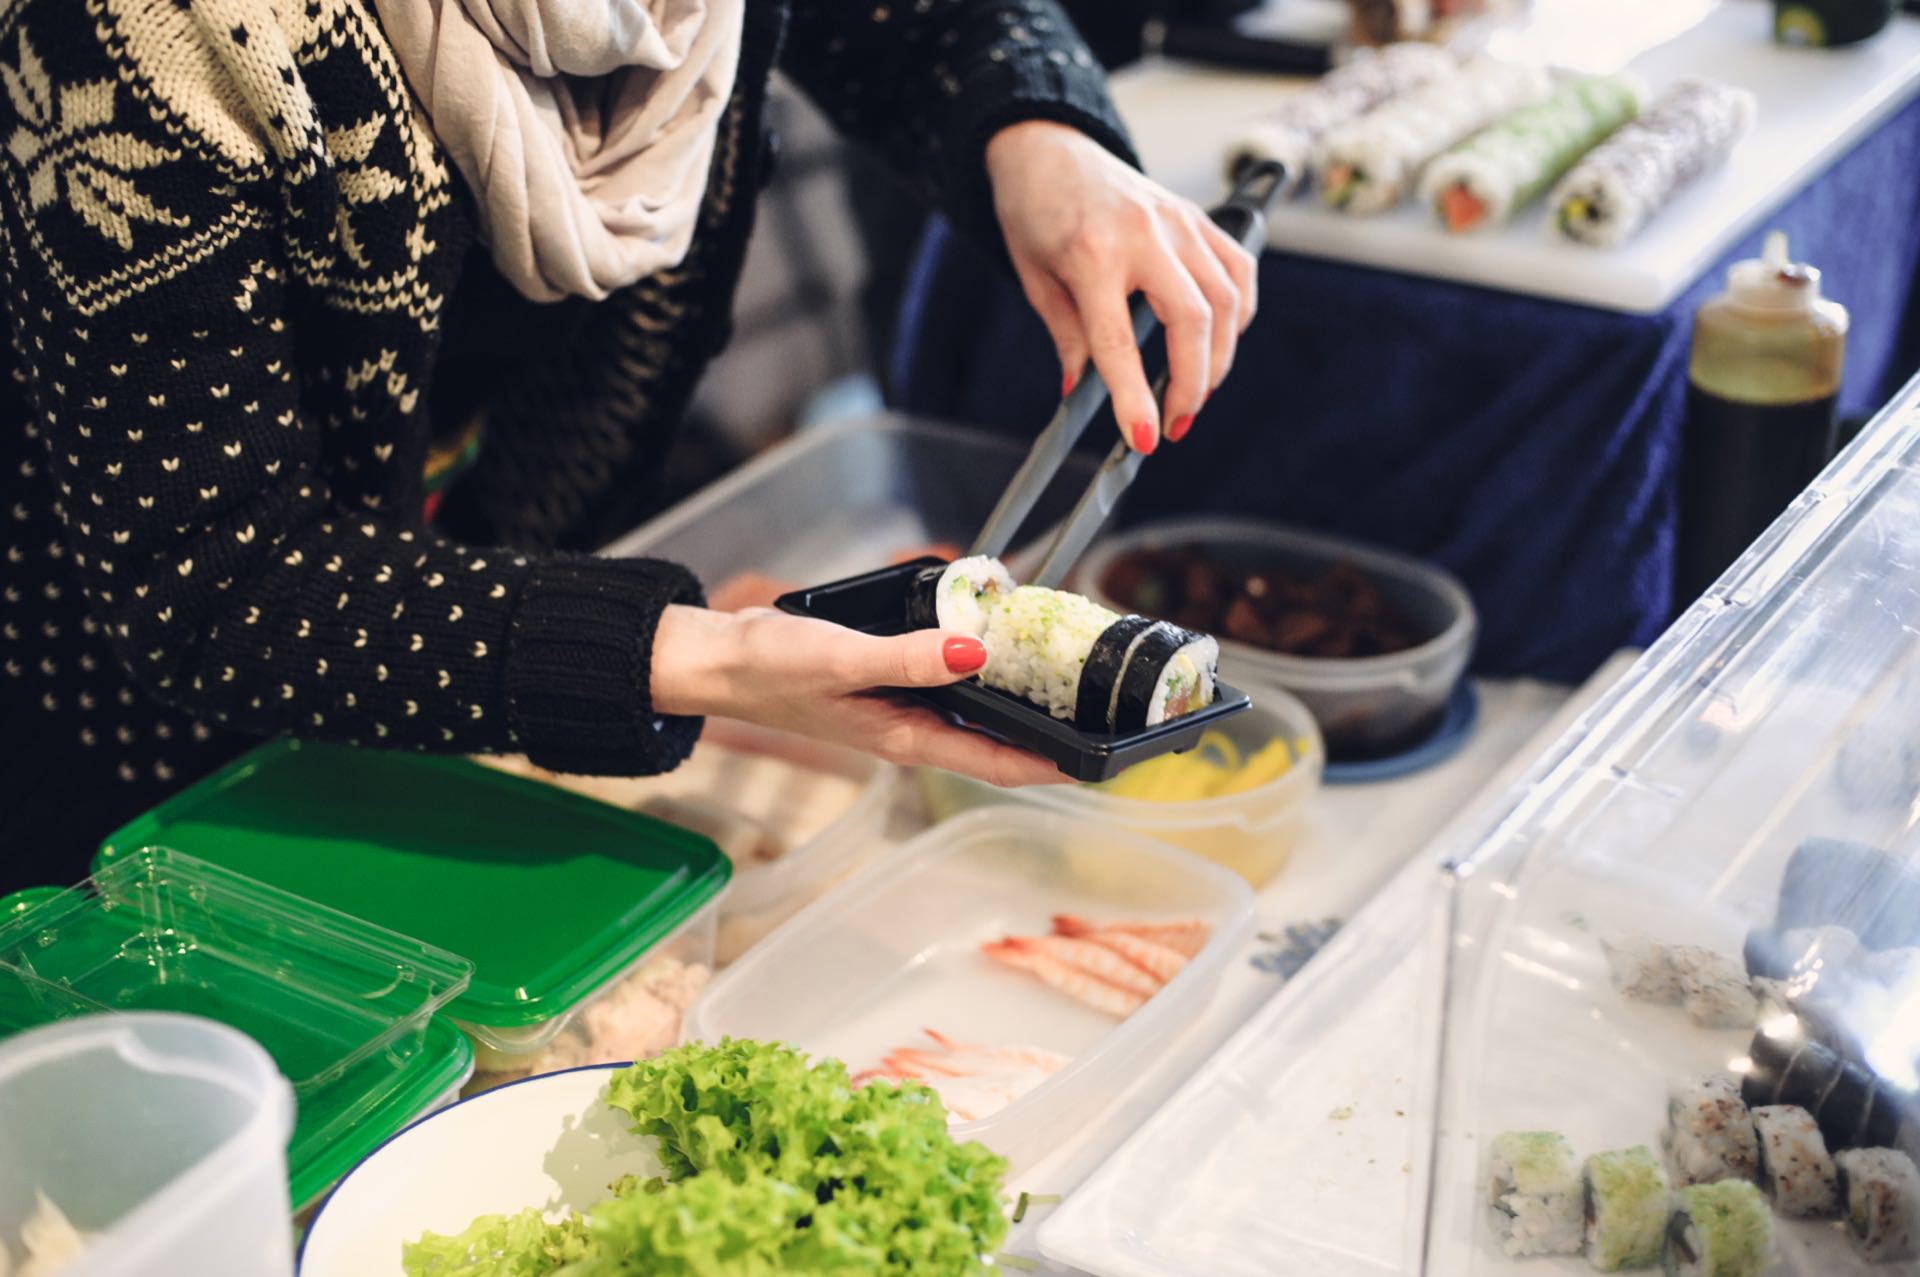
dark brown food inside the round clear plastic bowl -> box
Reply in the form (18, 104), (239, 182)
(1100, 545), (1434, 661)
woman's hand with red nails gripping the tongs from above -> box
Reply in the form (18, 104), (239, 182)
(987, 119), (1256, 453)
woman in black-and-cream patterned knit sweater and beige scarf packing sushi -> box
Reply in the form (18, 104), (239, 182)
(0, 0), (1254, 887)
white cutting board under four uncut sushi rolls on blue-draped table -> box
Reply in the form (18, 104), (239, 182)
(1114, 0), (1920, 313)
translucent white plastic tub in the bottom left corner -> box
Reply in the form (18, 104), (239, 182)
(0, 1012), (294, 1277)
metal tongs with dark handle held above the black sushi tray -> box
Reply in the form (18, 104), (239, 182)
(968, 161), (1286, 572)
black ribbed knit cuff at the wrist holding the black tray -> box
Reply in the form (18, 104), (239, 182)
(507, 559), (705, 776)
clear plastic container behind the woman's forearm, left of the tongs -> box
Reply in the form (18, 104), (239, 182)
(605, 415), (1100, 583)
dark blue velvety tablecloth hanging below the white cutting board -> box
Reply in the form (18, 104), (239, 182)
(889, 102), (1920, 680)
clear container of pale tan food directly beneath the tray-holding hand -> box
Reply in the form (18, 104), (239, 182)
(482, 718), (899, 966)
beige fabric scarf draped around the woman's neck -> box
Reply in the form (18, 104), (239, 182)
(374, 0), (745, 301)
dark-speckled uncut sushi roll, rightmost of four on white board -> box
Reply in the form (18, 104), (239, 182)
(1551, 79), (1753, 248)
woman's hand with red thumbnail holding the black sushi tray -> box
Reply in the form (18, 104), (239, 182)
(653, 605), (1066, 785)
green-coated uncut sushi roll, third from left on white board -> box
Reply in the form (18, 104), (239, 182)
(1421, 75), (1645, 234)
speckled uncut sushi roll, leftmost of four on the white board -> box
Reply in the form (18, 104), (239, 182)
(1227, 42), (1459, 194)
